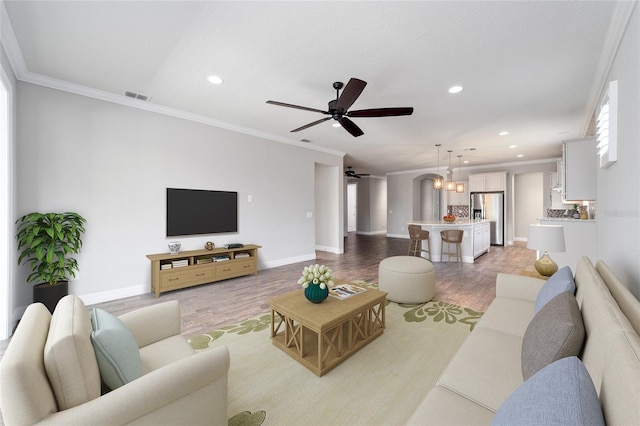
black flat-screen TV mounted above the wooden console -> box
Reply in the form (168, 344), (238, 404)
(167, 188), (238, 237)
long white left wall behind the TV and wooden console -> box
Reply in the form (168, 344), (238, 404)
(14, 83), (343, 305)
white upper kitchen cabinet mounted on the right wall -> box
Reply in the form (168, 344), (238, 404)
(562, 137), (598, 201)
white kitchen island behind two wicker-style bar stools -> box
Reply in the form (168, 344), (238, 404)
(408, 219), (491, 263)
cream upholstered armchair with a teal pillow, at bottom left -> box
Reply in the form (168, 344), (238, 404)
(0, 295), (229, 426)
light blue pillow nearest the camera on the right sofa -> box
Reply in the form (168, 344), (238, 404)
(491, 356), (604, 426)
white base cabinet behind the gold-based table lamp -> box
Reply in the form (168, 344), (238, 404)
(538, 217), (598, 270)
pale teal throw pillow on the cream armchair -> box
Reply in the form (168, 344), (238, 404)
(91, 308), (142, 390)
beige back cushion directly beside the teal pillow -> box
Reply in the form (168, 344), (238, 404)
(44, 295), (100, 410)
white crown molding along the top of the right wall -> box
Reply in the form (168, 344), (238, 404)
(581, 0), (638, 135)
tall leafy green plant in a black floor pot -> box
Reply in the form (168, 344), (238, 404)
(16, 212), (86, 312)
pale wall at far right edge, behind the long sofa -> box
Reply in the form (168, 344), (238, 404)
(596, 5), (640, 298)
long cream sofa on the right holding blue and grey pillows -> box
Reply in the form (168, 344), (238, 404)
(408, 257), (640, 425)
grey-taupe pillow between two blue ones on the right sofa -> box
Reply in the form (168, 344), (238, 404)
(521, 291), (584, 380)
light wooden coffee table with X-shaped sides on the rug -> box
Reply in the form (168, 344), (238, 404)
(269, 289), (387, 376)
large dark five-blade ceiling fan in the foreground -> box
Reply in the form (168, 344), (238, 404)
(267, 78), (413, 137)
